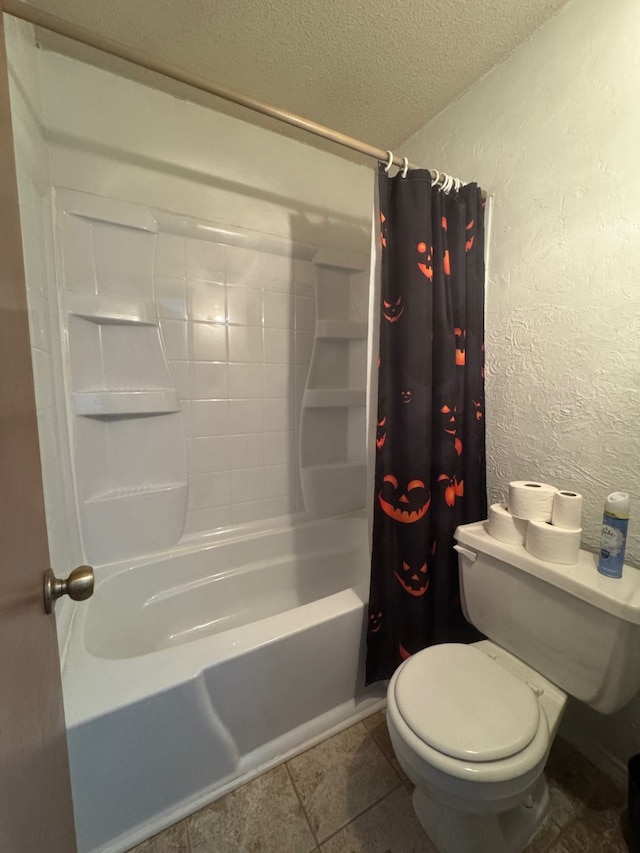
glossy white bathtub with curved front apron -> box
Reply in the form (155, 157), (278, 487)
(63, 517), (384, 853)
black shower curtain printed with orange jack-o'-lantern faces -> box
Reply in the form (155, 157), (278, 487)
(366, 167), (487, 683)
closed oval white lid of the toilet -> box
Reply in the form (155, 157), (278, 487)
(394, 643), (540, 762)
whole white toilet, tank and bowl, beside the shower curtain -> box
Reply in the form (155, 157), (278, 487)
(387, 522), (640, 853)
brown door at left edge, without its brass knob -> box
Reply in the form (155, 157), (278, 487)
(0, 13), (76, 853)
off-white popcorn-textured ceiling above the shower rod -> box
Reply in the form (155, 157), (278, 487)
(25, 0), (566, 153)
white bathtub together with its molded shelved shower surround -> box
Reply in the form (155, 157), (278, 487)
(46, 195), (383, 853)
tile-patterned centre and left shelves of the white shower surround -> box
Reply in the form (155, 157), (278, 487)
(56, 190), (328, 564)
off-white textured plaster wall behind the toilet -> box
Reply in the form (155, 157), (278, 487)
(401, 0), (640, 773)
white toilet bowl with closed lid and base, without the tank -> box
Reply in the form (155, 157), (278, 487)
(387, 640), (566, 853)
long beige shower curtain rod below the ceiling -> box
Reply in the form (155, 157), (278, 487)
(0, 0), (485, 196)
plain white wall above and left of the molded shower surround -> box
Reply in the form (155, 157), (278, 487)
(7, 18), (373, 632)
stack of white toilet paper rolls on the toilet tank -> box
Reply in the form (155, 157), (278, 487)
(487, 480), (582, 565)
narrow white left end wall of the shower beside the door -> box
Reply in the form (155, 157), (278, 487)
(5, 16), (84, 651)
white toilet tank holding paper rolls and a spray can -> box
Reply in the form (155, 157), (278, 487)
(455, 522), (640, 714)
